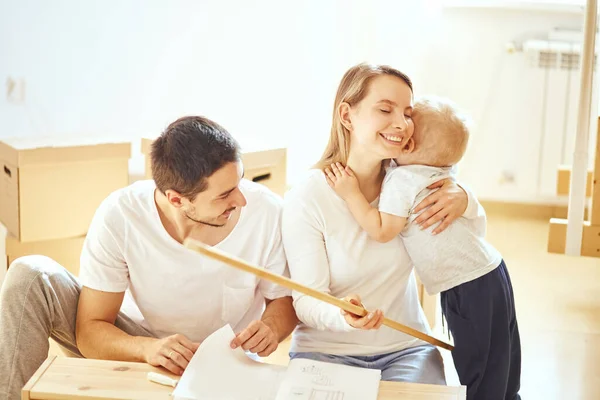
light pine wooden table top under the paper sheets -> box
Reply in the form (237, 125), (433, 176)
(22, 357), (466, 400)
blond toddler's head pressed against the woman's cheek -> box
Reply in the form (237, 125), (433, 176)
(396, 96), (469, 167)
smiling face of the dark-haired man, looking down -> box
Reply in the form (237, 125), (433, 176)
(181, 161), (246, 227)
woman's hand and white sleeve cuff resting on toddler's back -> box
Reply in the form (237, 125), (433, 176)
(414, 178), (480, 234)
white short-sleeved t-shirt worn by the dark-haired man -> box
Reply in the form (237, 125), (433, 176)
(80, 180), (291, 342)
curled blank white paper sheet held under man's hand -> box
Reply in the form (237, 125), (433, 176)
(173, 325), (286, 400)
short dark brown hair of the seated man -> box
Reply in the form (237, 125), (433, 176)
(151, 116), (240, 200)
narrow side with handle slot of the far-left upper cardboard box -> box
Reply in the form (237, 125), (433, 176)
(0, 160), (20, 241)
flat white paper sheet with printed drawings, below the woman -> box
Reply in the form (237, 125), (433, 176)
(276, 358), (381, 400)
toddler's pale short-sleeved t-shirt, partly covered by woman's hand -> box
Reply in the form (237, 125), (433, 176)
(379, 165), (502, 295)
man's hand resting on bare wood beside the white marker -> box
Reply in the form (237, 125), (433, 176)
(144, 334), (200, 375)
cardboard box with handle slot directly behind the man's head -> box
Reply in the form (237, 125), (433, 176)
(142, 138), (287, 196)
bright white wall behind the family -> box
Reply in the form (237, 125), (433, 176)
(0, 0), (596, 201)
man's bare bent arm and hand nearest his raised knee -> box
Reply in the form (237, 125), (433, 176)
(75, 286), (199, 375)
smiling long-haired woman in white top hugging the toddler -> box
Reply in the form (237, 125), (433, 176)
(282, 64), (477, 385)
